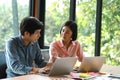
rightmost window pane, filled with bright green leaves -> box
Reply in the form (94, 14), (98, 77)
(101, 0), (120, 65)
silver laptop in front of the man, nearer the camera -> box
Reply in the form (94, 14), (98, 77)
(37, 57), (77, 76)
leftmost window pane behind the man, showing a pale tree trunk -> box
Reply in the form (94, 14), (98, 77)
(0, 0), (29, 51)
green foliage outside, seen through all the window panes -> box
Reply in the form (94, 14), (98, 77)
(0, 0), (120, 65)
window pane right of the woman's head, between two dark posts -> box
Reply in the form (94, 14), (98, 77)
(76, 0), (96, 56)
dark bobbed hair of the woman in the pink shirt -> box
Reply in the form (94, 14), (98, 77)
(60, 20), (77, 41)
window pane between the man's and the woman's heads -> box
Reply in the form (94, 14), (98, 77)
(44, 0), (70, 46)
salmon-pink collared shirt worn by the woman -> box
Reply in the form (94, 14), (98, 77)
(49, 40), (83, 62)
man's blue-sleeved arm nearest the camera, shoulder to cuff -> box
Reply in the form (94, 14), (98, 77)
(5, 39), (32, 74)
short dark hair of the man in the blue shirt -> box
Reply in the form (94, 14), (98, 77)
(20, 16), (43, 35)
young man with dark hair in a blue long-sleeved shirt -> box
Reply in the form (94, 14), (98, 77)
(5, 17), (46, 77)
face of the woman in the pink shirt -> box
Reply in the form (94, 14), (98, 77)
(61, 26), (72, 41)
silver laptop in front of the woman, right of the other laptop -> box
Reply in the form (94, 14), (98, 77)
(78, 56), (106, 72)
